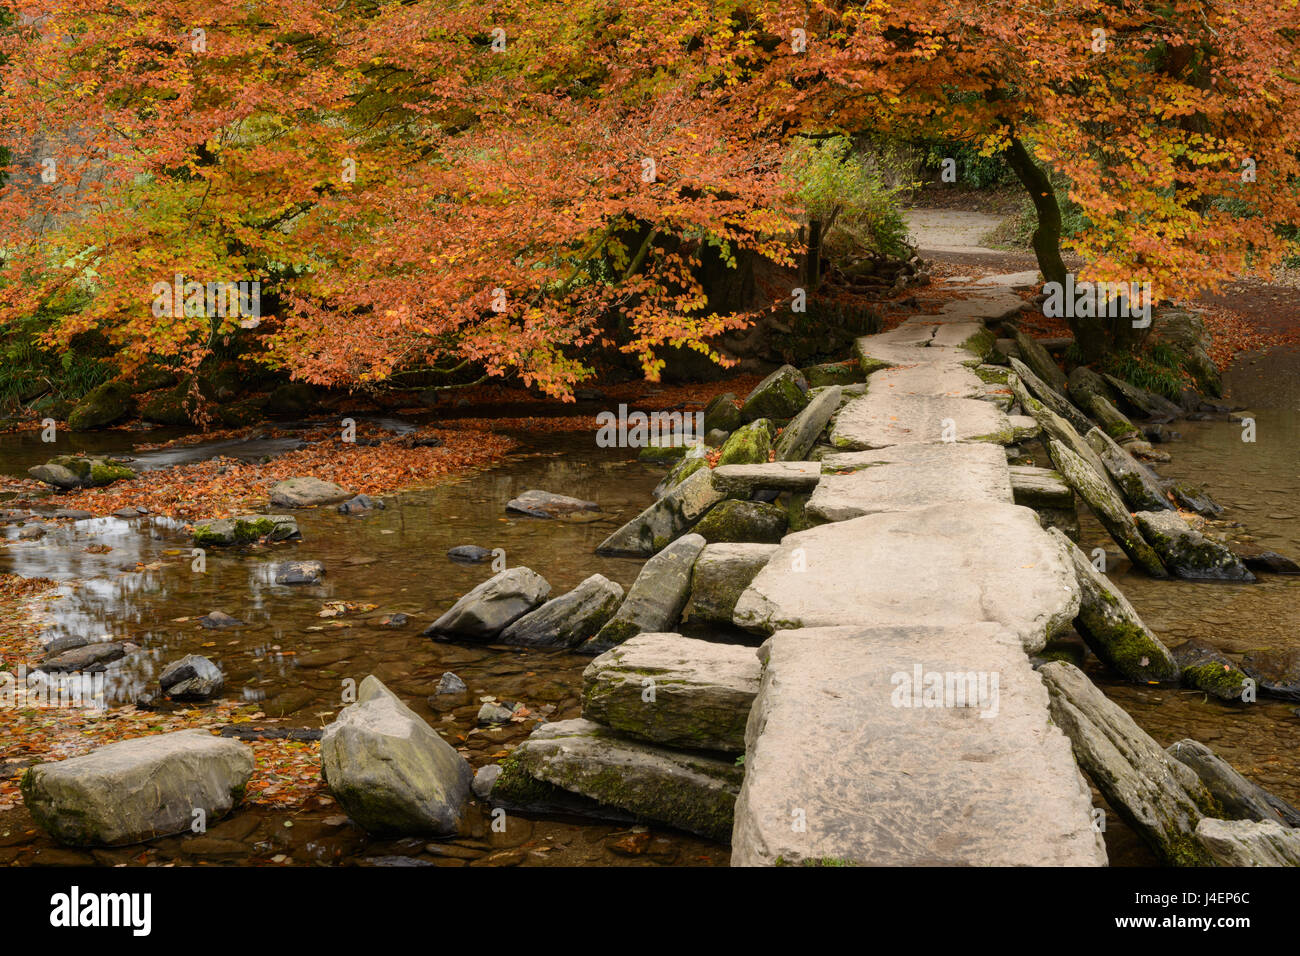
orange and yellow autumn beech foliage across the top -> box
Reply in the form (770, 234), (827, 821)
(0, 0), (1300, 395)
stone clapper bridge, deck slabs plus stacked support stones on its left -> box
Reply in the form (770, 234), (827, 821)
(491, 274), (1106, 866)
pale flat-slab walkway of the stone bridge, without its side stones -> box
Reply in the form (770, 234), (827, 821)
(732, 284), (1106, 866)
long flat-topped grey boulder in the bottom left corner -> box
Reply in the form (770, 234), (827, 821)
(22, 730), (254, 847)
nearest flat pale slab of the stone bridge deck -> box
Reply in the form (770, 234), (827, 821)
(732, 622), (1106, 866)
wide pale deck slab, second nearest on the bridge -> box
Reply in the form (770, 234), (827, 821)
(733, 501), (1079, 653)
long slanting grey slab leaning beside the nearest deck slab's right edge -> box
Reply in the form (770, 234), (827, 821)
(1039, 661), (1217, 866)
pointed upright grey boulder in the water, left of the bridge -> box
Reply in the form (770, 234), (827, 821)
(321, 674), (473, 836)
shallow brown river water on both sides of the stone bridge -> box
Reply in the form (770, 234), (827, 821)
(0, 352), (1300, 866)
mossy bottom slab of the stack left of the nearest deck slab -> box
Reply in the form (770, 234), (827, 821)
(491, 719), (744, 843)
